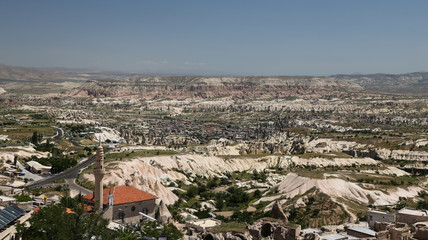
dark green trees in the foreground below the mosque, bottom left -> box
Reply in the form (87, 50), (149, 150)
(17, 195), (183, 240)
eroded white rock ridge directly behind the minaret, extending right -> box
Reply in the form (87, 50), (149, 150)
(83, 154), (377, 204)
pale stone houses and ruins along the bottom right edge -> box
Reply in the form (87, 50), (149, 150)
(186, 203), (428, 240)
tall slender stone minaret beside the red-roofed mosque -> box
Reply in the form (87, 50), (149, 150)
(94, 139), (105, 210)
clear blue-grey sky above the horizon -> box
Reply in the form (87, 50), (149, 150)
(0, 0), (428, 75)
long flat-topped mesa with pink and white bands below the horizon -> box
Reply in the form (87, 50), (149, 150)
(68, 77), (362, 99)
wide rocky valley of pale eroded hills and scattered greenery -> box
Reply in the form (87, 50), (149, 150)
(0, 65), (428, 238)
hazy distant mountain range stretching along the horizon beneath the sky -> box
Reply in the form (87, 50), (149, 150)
(0, 64), (428, 96)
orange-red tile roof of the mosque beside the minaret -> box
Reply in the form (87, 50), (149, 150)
(83, 186), (158, 205)
